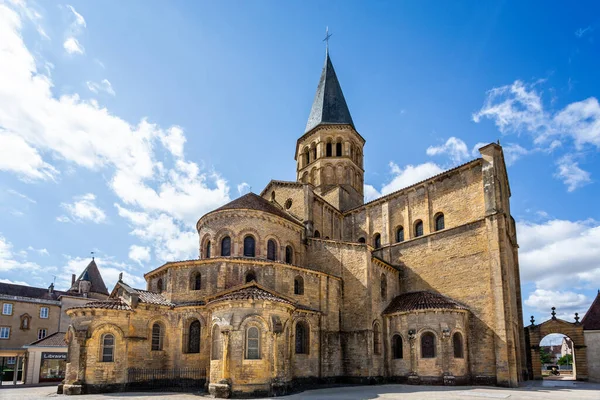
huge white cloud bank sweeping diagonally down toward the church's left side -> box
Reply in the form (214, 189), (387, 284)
(0, 5), (229, 259)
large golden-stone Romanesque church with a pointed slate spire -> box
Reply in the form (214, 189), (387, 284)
(65, 50), (527, 397)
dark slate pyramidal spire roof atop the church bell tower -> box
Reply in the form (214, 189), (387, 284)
(306, 52), (354, 132)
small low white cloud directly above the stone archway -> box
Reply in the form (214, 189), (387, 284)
(525, 289), (589, 322)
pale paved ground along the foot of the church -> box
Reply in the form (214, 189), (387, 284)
(0, 381), (600, 400)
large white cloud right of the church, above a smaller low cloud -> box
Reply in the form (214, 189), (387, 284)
(517, 219), (600, 291)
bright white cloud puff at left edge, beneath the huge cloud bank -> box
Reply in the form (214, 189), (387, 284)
(0, 132), (59, 181)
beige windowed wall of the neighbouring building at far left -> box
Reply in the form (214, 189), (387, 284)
(0, 299), (60, 350)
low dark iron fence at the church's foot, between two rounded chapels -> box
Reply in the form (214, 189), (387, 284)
(127, 368), (206, 391)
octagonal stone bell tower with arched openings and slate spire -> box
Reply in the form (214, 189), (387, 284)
(295, 49), (365, 211)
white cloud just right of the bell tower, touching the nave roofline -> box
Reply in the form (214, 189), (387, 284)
(364, 162), (444, 201)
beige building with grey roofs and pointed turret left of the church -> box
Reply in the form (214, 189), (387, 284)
(0, 260), (108, 383)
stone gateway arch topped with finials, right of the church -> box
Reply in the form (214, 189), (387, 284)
(525, 307), (588, 381)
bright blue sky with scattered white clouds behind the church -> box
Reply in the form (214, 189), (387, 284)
(0, 0), (600, 320)
